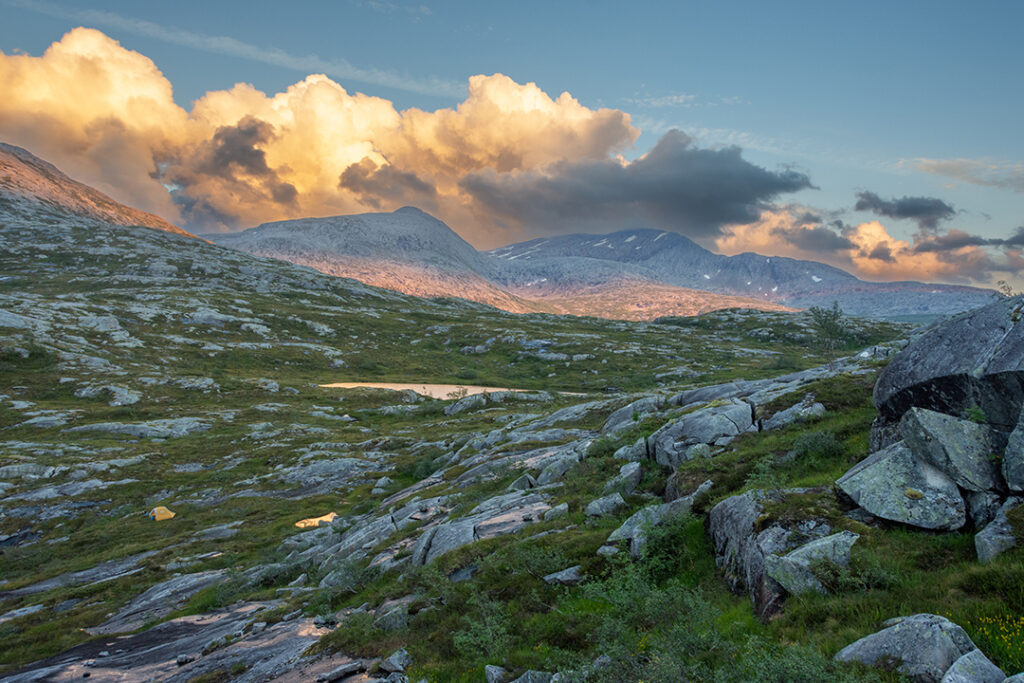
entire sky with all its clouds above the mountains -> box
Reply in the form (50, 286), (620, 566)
(0, 0), (1024, 290)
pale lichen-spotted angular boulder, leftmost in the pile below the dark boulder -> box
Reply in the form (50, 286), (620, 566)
(836, 441), (967, 531)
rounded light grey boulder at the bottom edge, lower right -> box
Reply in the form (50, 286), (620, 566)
(836, 614), (977, 683)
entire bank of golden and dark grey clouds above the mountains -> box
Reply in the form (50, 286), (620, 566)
(0, 28), (1024, 282)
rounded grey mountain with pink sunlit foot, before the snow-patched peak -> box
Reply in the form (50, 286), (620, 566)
(206, 207), (787, 319)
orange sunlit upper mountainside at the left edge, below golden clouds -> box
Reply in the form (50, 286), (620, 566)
(0, 142), (195, 237)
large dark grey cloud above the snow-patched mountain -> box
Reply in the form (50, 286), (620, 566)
(459, 130), (813, 239)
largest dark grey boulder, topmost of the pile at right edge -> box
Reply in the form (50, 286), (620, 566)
(874, 296), (1024, 430)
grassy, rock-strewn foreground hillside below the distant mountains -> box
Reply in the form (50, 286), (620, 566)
(0, 145), (1024, 683)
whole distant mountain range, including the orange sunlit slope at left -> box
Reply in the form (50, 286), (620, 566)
(0, 142), (998, 319)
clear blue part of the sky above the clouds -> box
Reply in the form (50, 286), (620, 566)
(0, 0), (1024, 282)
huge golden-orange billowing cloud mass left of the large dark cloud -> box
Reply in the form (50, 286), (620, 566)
(0, 28), (640, 243)
